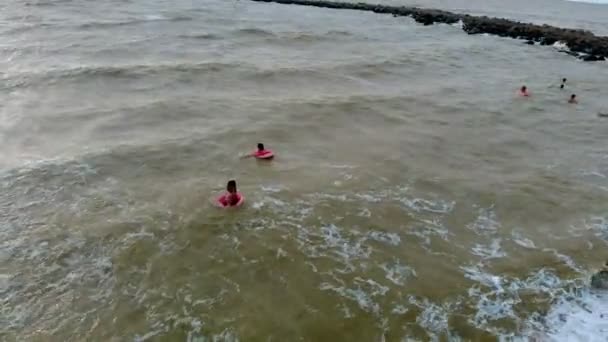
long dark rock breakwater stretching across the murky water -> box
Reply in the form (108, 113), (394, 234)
(251, 0), (608, 61)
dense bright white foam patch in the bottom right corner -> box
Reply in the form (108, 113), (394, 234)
(461, 253), (608, 342)
